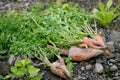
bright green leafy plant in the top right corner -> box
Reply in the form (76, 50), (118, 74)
(93, 0), (120, 26)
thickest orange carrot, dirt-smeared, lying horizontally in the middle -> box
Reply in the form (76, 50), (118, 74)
(68, 47), (103, 61)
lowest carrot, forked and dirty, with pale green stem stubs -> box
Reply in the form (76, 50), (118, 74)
(37, 55), (72, 80)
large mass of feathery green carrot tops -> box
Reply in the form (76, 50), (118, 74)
(0, 3), (95, 59)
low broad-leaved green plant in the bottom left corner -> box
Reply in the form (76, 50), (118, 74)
(4, 59), (41, 80)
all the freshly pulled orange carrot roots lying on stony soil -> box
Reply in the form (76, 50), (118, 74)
(37, 32), (111, 80)
